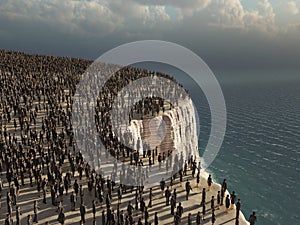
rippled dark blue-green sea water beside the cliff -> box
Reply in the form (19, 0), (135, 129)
(133, 63), (300, 225)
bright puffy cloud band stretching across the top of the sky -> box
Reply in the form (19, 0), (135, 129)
(0, 0), (298, 37)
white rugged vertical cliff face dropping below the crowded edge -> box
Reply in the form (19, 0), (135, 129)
(128, 98), (199, 163)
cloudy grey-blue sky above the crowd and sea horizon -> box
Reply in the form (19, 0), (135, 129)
(0, 0), (300, 70)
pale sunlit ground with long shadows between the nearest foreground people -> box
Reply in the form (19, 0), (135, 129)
(0, 162), (248, 225)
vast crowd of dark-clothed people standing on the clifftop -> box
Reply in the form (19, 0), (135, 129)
(0, 50), (256, 225)
